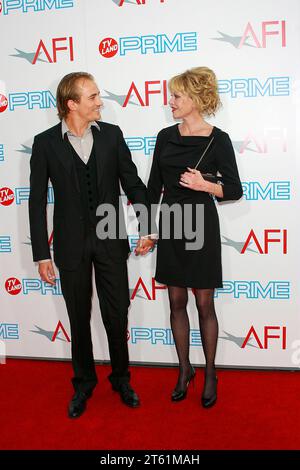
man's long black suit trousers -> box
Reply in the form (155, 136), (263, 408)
(59, 228), (130, 392)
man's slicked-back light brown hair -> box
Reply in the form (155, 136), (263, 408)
(56, 72), (94, 120)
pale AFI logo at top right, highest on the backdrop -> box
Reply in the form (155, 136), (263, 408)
(212, 20), (286, 49)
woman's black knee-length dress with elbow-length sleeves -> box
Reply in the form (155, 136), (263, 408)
(148, 124), (242, 289)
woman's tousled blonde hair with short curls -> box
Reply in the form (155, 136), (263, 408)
(169, 67), (221, 116)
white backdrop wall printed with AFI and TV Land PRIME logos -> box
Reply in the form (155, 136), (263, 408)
(0, 0), (300, 368)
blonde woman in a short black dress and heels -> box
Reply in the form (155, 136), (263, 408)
(148, 67), (242, 408)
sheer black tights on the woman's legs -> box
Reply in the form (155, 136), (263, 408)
(168, 286), (218, 398)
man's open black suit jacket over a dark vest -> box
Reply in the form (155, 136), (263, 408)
(29, 122), (147, 270)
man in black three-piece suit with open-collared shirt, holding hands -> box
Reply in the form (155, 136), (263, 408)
(29, 72), (153, 418)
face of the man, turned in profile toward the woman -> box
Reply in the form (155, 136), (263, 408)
(73, 78), (103, 122)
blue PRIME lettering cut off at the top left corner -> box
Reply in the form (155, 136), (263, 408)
(0, 0), (74, 15)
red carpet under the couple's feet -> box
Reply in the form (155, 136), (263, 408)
(0, 360), (300, 450)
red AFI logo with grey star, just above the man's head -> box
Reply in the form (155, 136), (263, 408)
(10, 36), (74, 65)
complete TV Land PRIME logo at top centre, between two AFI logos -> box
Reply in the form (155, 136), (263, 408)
(99, 32), (197, 59)
